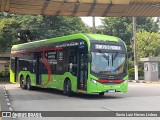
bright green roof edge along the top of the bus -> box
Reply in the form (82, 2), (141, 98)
(12, 33), (118, 49)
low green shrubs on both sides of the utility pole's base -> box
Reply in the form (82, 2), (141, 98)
(128, 68), (144, 80)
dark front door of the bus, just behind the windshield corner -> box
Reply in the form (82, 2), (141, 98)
(78, 53), (88, 90)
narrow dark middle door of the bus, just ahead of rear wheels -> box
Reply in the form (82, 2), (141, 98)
(35, 53), (41, 85)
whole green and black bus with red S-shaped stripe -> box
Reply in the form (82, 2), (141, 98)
(10, 34), (128, 96)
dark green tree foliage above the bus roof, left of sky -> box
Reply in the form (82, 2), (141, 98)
(0, 14), (89, 52)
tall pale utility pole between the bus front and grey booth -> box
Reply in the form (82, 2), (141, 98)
(133, 17), (138, 80)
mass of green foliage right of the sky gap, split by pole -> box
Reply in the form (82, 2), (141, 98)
(101, 17), (160, 72)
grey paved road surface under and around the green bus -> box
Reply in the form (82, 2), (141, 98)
(0, 83), (160, 120)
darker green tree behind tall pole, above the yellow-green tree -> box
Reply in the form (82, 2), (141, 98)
(102, 17), (158, 45)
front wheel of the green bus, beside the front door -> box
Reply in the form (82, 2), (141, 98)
(63, 80), (72, 97)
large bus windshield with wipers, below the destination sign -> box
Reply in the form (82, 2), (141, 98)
(91, 51), (126, 75)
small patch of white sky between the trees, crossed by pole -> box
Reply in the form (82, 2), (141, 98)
(81, 17), (103, 27)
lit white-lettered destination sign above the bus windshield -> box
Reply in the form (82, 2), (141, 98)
(95, 44), (122, 50)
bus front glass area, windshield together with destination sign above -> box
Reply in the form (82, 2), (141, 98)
(90, 44), (127, 77)
